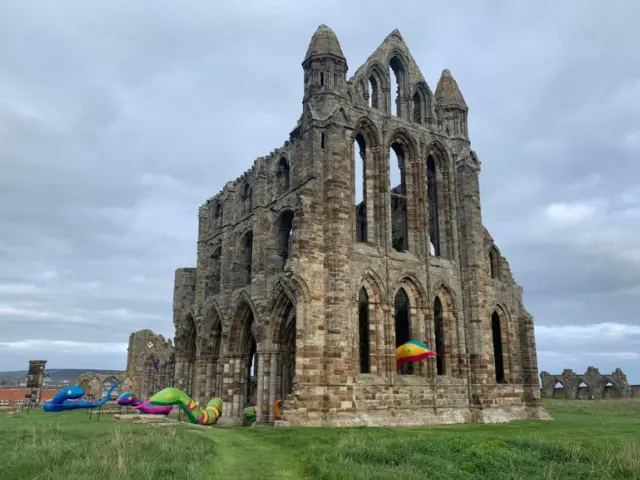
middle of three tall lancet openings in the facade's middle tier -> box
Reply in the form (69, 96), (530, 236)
(389, 142), (409, 252)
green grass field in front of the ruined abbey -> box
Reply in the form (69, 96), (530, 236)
(0, 401), (640, 480)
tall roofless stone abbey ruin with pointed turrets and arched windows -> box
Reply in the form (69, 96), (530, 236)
(174, 25), (548, 425)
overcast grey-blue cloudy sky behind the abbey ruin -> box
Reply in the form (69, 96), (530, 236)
(0, 0), (640, 383)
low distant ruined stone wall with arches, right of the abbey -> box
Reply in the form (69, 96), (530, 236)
(540, 367), (640, 400)
